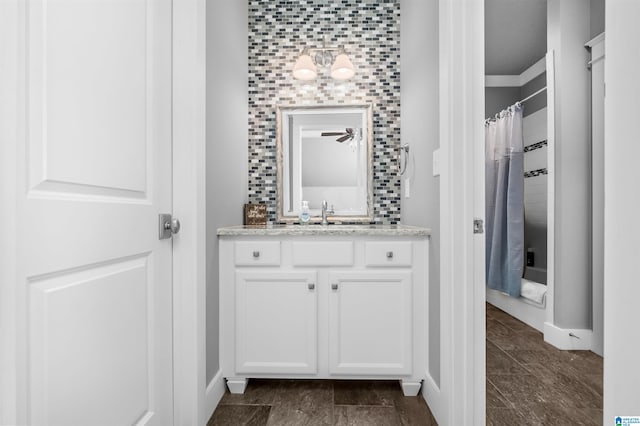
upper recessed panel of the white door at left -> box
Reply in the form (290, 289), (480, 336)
(27, 0), (152, 197)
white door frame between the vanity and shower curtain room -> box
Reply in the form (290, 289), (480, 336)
(438, 0), (486, 425)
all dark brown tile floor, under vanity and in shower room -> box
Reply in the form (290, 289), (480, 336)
(208, 304), (602, 426)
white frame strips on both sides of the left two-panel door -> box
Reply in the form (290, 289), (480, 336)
(0, 0), (207, 425)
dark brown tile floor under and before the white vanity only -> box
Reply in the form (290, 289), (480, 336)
(207, 380), (437, 426)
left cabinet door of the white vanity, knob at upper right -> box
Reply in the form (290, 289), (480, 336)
(235, 270), (318, 374)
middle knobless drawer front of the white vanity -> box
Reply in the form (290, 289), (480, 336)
(292, 241), (353, 266)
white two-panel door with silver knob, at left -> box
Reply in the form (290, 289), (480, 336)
(15, 0), (173, 425)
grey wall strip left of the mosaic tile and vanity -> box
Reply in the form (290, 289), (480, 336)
(206, 0), (248, 383)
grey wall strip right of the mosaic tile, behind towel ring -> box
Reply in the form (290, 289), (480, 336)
(400, 0), (440, 382)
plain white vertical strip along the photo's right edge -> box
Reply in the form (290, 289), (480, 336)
(604, 0), (640, 424)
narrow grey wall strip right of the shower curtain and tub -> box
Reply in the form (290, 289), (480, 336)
(547, 0), (591, 329)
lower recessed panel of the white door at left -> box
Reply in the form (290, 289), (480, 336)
(28, 256), (154, 424)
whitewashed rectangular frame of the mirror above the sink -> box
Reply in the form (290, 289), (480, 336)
(276, 104), (373, 223)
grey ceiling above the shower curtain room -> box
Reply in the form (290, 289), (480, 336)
(484, 0), (547, 75)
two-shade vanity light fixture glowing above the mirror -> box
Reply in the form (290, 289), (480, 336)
(293, 43), (355, 80)
